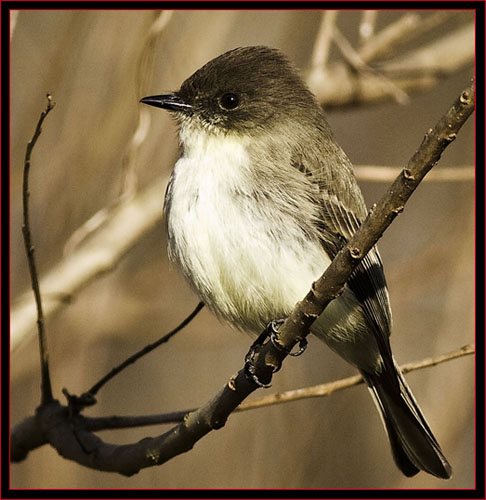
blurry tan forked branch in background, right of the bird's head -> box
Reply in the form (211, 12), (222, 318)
(307, 12), (475, 107)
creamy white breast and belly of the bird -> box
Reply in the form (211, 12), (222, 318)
(167, 134), (330, 332)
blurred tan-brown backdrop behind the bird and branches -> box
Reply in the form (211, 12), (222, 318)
(11, 11), (475, 488)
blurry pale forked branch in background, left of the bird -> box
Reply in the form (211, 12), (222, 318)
(10, 10), (173, 350)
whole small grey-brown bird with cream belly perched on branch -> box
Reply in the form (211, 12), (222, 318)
(141, 47), (451, 478)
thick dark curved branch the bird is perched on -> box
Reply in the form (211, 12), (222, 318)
(11, 82), (474, 475)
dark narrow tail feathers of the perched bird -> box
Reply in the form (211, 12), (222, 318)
(362, 365), (452, 479)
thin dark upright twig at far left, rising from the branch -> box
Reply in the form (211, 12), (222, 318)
(22, 94), (56, 404)
